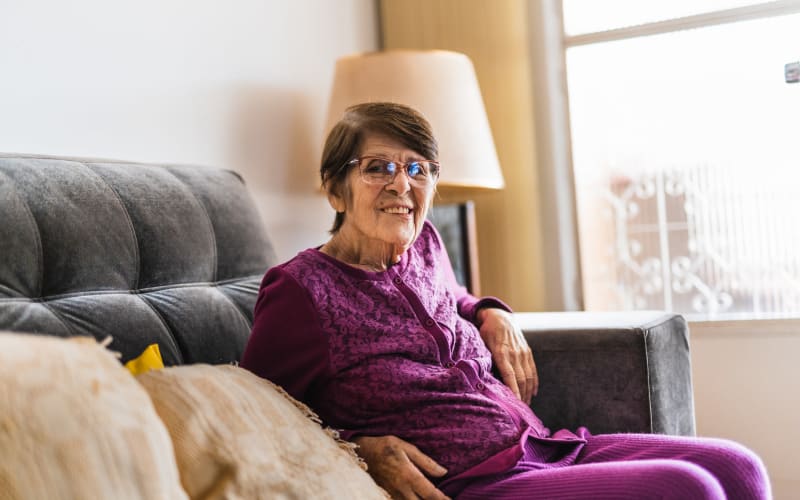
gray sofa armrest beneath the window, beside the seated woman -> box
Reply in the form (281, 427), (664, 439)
(515, 311), (695, 435)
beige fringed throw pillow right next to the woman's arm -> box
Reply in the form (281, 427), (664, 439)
(138, 365), (386, 500)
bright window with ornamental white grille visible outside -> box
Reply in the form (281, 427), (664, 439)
(562, 0), (800, 319)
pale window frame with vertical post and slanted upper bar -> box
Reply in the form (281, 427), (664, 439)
(529, 0), (800, 316)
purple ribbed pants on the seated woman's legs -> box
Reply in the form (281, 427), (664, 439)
(445, 430), (771, 500)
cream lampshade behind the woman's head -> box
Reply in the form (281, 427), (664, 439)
(325, 50), (504, 189)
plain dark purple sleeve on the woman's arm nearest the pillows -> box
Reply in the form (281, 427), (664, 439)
(241, 267), (329, 401)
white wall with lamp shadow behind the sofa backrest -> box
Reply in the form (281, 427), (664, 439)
(0, 0), (378, 260)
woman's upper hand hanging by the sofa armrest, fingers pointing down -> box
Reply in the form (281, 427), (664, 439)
(476, 308), (539, 404)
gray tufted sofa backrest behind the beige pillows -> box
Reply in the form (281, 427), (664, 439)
(0, 154), (275, 365)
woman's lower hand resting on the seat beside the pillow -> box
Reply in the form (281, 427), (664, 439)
(353, 436), (449, 500)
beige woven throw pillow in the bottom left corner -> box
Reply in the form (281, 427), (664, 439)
(0, 332), (186, 500)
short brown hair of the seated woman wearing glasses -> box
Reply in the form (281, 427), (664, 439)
(319, 102), (439, 233)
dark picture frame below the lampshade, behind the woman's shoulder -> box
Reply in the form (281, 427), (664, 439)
(428, 201), (480, 296)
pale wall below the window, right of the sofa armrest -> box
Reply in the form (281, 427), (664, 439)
(690, 321), (800, 500)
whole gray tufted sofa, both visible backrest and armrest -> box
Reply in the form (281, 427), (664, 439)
(0, 154), (694, 434)
